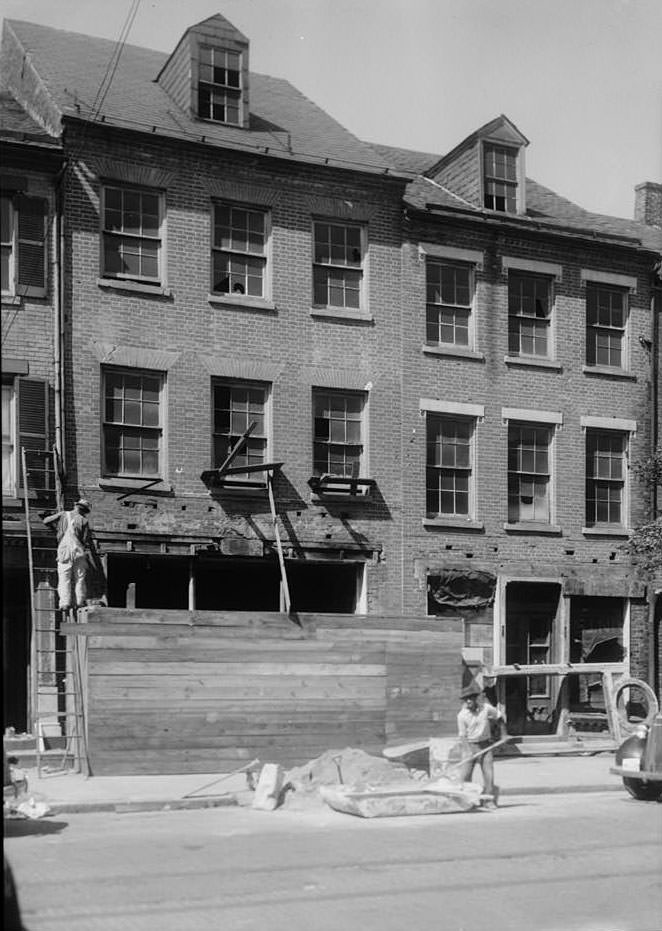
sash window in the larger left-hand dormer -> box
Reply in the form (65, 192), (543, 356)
(198, 45), (241, 126)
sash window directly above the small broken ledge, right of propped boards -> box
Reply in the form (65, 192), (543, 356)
(313, 391), (364, 478)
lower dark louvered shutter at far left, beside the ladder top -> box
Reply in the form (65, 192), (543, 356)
(16, 378), (52, 496)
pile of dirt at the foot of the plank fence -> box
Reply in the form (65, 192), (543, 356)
(285, 747), (416, 794)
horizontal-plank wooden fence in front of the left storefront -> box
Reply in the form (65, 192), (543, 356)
(67, 608), (463, 775)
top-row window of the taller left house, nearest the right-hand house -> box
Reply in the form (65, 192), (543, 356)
(313, 222), (364, 310)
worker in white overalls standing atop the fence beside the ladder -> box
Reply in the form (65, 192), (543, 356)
(44, 498), (92, 611)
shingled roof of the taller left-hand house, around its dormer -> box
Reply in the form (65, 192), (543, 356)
(3, 20), (410, 175)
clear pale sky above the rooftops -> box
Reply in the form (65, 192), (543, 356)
(0, 0), (662, 217)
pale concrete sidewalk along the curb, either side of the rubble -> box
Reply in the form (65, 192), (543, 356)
(6, 752), (624, 814)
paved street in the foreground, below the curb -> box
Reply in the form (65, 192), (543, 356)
(5, 792), (662, 931)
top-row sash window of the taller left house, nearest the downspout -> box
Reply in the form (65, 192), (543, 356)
(101, 185), (163, 285)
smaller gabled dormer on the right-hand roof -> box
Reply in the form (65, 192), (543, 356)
(425, 115), (529, 214)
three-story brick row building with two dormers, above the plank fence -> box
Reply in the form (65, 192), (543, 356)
(2, 16), (662, 744)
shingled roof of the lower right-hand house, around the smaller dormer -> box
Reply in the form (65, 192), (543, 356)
(373, 145), (662, 252)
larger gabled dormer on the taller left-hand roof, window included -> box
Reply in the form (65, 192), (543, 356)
(156, 14), (250, 129)
